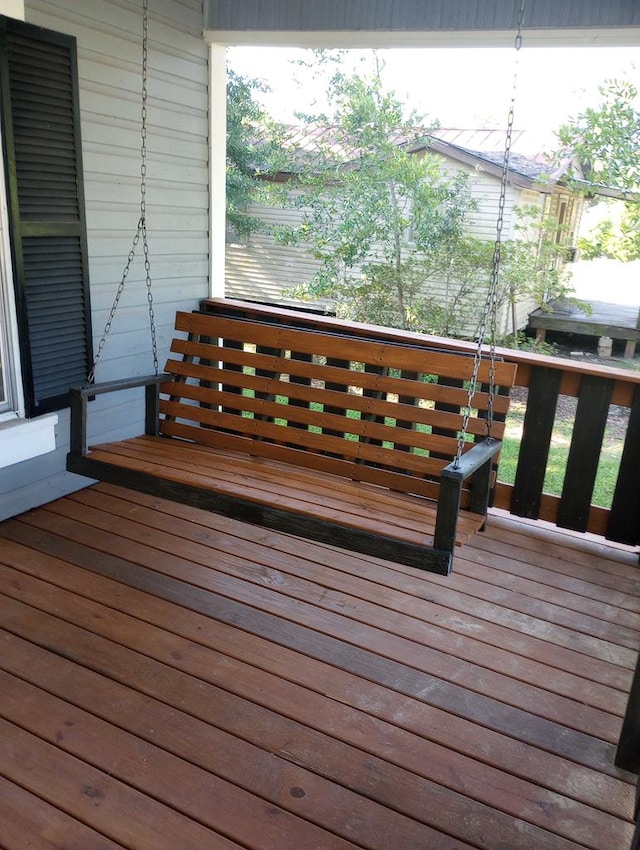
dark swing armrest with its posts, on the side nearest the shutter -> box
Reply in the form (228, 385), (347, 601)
(69, 373), (169, 457)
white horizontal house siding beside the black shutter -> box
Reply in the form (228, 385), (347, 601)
(0, 0), (209, 518)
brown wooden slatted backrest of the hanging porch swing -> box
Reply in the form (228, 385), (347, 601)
(160, 313), (515, 498)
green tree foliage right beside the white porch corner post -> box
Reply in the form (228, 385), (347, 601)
(226, 69), (284, 235)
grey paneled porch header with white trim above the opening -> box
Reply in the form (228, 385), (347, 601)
(205, 0), (640, 47)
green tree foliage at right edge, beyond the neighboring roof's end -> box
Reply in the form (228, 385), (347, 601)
(556, 80), (640, 261)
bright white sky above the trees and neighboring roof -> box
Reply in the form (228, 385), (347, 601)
(228, 45), (640, 139)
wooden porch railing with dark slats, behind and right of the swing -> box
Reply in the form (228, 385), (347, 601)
(202, 299), (640, 546)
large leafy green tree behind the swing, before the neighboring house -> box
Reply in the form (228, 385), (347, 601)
(275, 68), (474, 333)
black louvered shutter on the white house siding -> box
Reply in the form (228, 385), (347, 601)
(0, 18), (92, 416)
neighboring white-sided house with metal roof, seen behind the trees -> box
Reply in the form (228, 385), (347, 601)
(225, 128), (584, 333)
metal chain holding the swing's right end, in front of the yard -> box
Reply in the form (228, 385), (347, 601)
(454, 0), (525, 468)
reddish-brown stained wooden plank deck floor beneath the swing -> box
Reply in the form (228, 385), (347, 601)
(0, 485), (640, 850)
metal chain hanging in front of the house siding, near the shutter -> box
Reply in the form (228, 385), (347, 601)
(87, 0), (159, 385)
